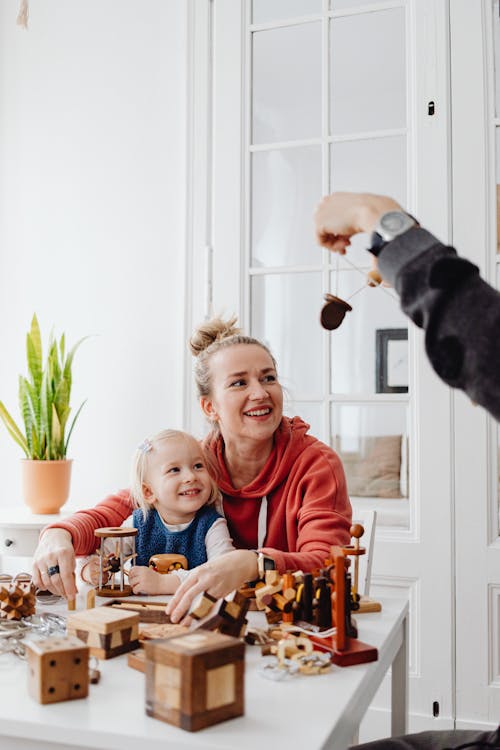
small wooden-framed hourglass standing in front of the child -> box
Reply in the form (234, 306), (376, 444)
(94, 526), (137, 596)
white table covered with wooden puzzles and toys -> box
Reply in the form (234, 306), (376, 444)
(0, 599), (408, 750)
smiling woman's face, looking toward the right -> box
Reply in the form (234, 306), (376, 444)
(201, 344), (283, 443)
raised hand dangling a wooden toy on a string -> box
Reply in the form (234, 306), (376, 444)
(314, 193), (401, 255)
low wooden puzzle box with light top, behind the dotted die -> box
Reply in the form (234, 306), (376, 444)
(67, 607), (139, 659)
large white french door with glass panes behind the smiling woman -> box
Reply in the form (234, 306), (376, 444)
(186, 0), (454, 736)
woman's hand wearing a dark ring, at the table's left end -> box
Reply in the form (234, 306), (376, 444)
(33, 529), (78, 600)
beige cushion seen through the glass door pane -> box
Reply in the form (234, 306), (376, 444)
(336, 435), (402, 498)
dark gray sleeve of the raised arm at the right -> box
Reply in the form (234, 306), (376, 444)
(378, 228), (500, 421)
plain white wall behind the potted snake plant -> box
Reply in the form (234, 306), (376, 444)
(0, 0), (186, 507)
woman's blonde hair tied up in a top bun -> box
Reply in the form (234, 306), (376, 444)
(189, 315), (278, 396)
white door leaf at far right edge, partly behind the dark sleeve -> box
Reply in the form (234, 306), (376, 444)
(450, 0), (500, 728)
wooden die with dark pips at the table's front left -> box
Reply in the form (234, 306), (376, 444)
(26, 636), (89, 703)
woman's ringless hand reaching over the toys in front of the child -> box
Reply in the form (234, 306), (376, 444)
(167, 549), (258, 622)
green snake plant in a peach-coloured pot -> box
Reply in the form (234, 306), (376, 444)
(0, 315), (85, 514)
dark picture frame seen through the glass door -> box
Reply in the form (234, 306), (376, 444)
(375, 328), (408, 393)
